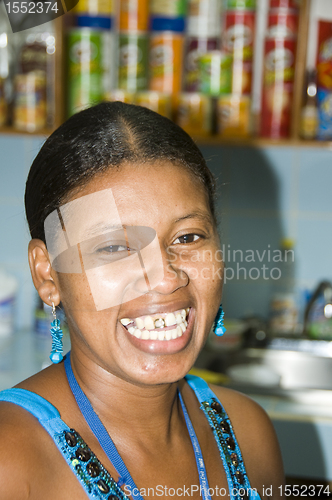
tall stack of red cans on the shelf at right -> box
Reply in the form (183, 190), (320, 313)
(260, 0), (299, 139)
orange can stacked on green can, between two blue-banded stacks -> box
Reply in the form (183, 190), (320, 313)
(117, 0), (149, 94)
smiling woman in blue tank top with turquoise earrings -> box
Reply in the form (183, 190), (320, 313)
(0, 102), (283, 500)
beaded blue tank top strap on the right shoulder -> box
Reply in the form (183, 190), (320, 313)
(185, 375), (260, 500)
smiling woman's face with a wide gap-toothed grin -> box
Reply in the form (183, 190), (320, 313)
(54, 162), (223, 385)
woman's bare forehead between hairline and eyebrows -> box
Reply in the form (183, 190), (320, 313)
(68, 162), (210, 226)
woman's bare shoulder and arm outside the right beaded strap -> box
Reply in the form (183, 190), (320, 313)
(211, 386), (284, 498)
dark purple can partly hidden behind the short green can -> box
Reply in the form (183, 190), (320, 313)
(184, 37), (219, 92)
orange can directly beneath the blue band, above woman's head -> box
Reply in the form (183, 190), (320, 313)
(149, 31), (184, 94)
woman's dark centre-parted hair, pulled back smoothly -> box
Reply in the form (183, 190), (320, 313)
(25, 102), (215, 242)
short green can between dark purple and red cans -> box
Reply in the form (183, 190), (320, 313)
(198, 50), (233, 96)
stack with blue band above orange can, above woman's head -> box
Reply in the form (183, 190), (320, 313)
(149, 0), (186, 114)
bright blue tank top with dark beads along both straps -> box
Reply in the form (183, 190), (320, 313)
(0, 375), (260, 500)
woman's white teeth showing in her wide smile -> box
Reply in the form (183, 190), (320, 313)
(120, 307), (190, 340)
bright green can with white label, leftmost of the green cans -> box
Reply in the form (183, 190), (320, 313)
(68, 28), (105, 116)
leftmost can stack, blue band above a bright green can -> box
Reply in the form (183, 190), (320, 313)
(67, 5), (114, 116)
